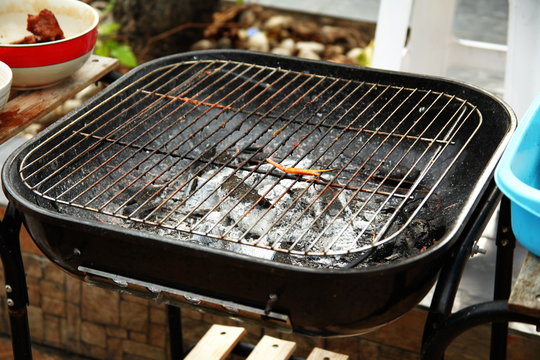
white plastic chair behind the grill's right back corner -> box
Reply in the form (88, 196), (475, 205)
(372, 0), (540, 119)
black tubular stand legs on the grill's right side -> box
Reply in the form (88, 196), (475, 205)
(421, 195), (540, 360)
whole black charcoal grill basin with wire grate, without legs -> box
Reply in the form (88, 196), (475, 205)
(2, 51), (515, 346)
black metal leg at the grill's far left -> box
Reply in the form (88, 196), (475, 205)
(0, 204), (32, 360)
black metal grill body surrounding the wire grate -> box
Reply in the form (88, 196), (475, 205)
(2, 51), (515, 336)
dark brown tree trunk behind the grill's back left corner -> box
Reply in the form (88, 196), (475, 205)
(113, 0), (220, 62)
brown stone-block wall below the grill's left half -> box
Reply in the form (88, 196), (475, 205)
(1, 249), (167, 360)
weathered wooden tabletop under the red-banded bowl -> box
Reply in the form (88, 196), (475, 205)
(0, 55), (119, 144)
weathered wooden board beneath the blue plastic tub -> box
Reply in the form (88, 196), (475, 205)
(508, 253), (540, 317)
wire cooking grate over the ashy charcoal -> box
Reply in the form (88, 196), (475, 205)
(20, 61), (482, 255)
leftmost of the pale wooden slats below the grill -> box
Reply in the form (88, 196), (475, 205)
(185, 325), (247, 360)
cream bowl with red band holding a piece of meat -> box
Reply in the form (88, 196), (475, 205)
(0, 0), (99, 90)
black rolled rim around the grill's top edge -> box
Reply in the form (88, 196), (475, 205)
(2, 50), (517, 273)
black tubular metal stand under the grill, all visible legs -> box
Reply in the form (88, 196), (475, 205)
(0, 181), (540, 360)
